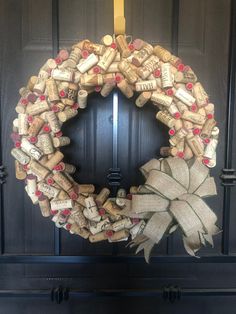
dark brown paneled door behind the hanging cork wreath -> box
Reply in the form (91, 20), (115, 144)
(0, 0), (236, 314)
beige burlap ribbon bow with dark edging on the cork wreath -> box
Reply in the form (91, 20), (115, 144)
(123, 157), (220, 262)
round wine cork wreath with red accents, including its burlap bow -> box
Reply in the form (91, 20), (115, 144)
(11, 35), (219, 261)
